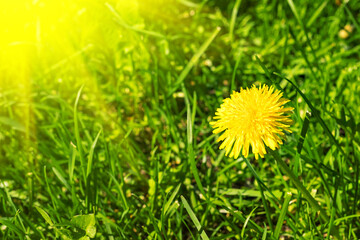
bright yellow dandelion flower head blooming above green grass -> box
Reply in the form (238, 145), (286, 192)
(210, 85), (293, 159)
